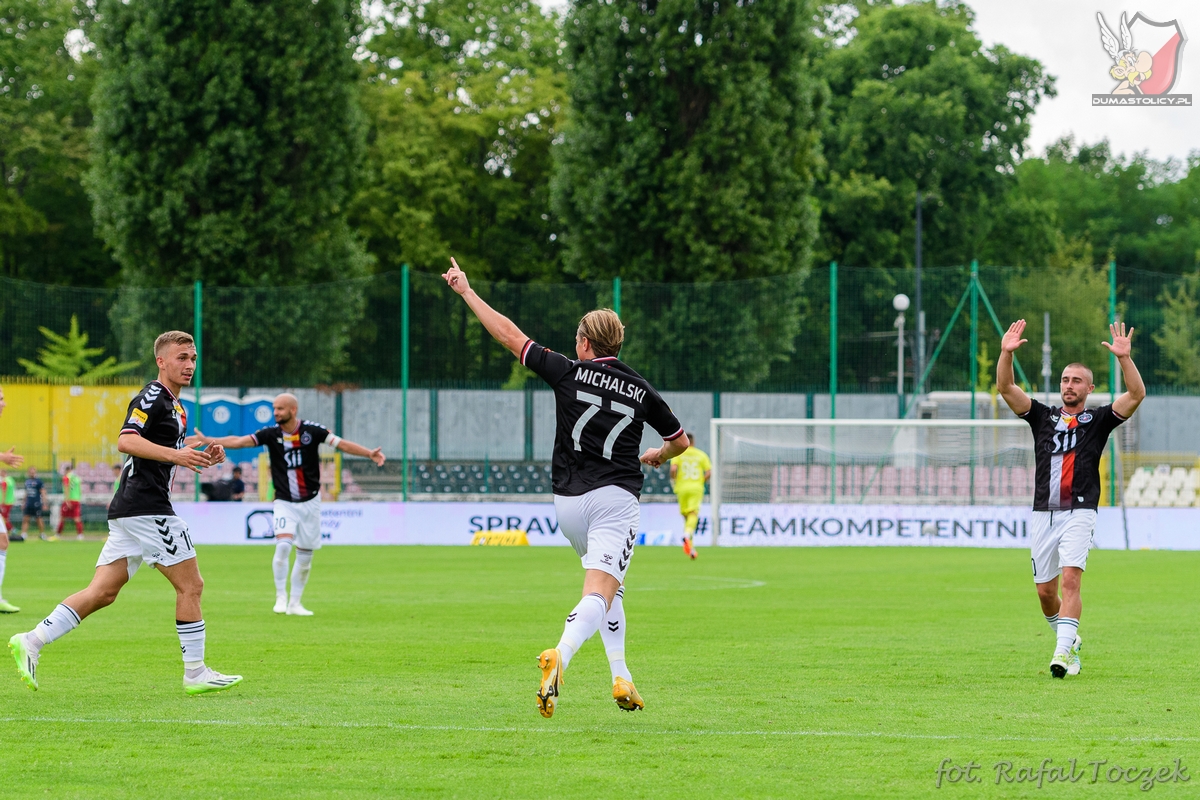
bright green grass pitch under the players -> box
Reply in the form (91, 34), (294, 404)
(0, 542), (1200, 800)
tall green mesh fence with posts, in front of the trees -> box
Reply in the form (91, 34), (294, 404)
(0, 265), (1200, 395)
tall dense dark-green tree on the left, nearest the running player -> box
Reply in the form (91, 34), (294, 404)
(89, 0), (368, 381)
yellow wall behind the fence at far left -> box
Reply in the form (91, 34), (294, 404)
(0, 383), (140, 470)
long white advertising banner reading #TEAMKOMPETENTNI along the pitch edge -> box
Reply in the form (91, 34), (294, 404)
(175, 503), (1200, 549)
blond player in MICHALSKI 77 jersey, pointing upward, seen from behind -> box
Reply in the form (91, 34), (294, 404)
(442, 259), (688, 717)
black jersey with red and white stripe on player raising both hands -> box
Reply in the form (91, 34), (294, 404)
(1021, 397), (1126, 511)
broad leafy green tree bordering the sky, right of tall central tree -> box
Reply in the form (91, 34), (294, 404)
(818, 0), (1054, 267)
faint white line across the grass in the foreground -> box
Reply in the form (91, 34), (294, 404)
(0, 717), (1200, 744)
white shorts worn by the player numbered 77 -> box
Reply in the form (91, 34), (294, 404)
(554, 486), (642, 582)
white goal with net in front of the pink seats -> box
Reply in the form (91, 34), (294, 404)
(709, 419), (1034, 543)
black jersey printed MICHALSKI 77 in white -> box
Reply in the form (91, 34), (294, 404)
(521, 339), (683, 497)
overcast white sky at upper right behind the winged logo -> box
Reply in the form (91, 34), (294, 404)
(539, 0), (1200, 161)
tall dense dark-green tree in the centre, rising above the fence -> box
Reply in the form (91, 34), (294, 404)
(553, 0), (823, 282)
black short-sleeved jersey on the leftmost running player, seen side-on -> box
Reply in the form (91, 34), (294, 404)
(108, 380), (187, 519)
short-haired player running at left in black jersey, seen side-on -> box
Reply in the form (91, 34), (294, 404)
(8, 331), (241, 694)
